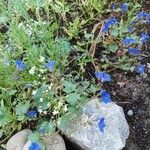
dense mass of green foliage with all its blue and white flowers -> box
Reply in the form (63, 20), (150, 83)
(0, 0), (150, 149)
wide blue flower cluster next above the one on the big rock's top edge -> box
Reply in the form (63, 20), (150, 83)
(95, 71), (111, 82)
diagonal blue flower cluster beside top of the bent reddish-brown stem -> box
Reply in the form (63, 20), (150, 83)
(102, 17), (118, 32)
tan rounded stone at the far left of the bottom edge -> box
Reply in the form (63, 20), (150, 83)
(6, 129), (31, 150)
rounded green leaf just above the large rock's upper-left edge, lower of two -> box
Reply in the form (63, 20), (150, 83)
(66, 93), (80, 105)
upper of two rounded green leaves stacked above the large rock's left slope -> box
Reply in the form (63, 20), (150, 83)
(63, 80), (77, 93)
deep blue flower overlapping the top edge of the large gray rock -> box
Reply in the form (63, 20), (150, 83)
(100, 90), (111, 104)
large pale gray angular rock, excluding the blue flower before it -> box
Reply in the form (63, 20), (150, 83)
(62, 99), (129, 150)
